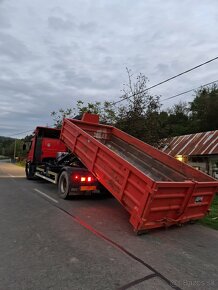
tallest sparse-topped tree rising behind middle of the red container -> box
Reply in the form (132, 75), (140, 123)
(116, 68), (161, 146)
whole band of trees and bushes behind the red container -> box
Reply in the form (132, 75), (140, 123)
(51, 69), (218, 147)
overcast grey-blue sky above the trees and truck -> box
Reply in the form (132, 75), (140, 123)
(0, 0), (218, 137)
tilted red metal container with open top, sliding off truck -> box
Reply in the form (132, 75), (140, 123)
(61, 114), (218, 232)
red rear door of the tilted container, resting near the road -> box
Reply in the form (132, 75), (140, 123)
(139, 181), (218, 229)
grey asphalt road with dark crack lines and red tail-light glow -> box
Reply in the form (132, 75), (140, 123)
(0, 163), (218, 290)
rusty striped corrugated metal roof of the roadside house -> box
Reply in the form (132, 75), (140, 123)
(162, 130), (218, 156)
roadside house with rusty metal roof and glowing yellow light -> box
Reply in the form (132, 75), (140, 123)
(162, 130), (218, 179)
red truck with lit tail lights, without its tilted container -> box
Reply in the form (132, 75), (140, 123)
(23, 119), (100, 199)
